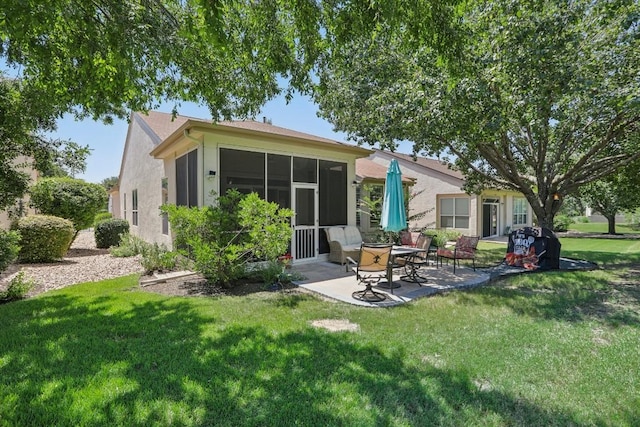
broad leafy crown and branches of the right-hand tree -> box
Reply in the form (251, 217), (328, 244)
(317, 0), (640, 228)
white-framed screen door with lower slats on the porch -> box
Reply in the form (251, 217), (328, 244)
(291, 184), (318, 261)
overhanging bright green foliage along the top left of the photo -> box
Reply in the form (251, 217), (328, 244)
(0, 0), (456, 120)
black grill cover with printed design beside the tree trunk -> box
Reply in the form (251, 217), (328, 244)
(505, 227), (560, 270)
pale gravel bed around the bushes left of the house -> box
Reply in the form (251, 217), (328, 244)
(0, 230), (143, 296)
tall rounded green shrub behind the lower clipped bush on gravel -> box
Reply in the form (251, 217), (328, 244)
(30, 178), (108, 236)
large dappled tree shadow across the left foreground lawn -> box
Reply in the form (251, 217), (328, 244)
(0, 295), (624, 426)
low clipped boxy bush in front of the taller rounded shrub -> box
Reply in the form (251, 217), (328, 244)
(14, 215), (76, 263)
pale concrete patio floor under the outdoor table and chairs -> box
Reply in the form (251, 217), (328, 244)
(294, 262), (491, 307)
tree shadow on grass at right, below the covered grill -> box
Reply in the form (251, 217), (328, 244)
(460, 266), (640, 326)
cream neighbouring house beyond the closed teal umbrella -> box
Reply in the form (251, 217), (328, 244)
(356, 150), (533, 238)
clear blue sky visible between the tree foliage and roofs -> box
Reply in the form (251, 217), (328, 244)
(52, 95), (410, 183)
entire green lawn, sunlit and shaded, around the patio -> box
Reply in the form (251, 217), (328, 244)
(0, 239), (640, 426)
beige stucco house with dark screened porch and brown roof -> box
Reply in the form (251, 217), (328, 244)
(111, 111), (372, 261)
